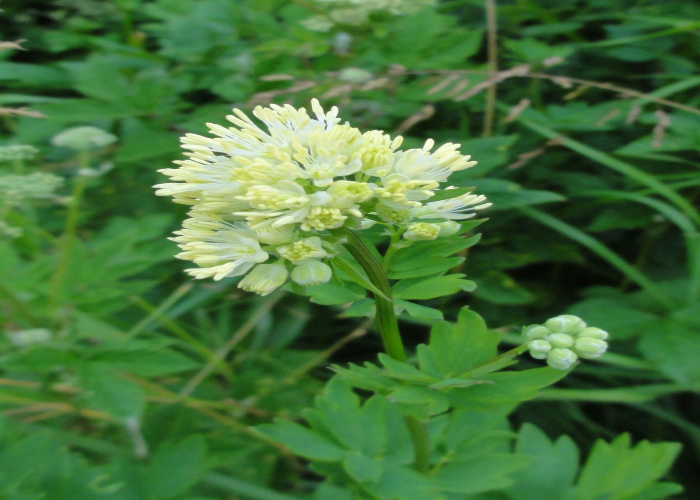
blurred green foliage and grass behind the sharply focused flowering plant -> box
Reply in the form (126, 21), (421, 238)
(0, 0), (700, 500)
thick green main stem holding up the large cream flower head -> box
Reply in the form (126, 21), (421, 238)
(336, 227), (430, 474)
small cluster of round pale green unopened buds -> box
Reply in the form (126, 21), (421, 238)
(523, 315), (608, 370)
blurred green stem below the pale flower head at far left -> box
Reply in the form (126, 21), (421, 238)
(50, 151), (90, 307)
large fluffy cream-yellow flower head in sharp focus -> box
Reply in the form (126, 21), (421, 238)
(155, 99), (490, 295)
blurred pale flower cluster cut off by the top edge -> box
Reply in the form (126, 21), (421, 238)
(302, 0), (436, 31)
